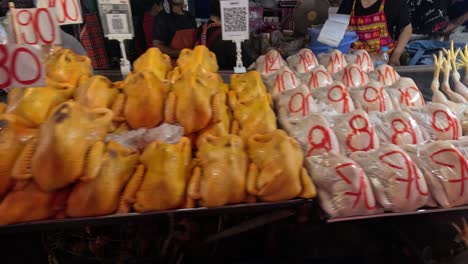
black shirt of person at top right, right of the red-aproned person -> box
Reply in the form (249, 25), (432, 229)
(407, 0), (450, 34)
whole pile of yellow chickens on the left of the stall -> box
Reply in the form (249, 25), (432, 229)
(0, 46), (315, 225)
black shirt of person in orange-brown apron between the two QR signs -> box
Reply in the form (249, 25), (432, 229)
(153, 11), (197, 46)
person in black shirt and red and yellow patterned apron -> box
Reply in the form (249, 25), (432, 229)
(338, 0), (412, 65)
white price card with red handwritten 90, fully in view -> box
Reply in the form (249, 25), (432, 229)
(13, 8), (61, 45)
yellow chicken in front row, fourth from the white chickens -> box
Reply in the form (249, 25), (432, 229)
(66, 141), (138, 217)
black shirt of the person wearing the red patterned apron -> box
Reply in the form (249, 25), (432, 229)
(338, 0), (411, 40)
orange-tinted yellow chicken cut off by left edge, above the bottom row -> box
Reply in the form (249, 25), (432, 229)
(0, 114), (37, 200)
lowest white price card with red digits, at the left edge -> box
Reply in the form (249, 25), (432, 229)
(0, 44), (45, 90)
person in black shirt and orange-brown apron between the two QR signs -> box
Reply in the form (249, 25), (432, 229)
(153, 0), (197, 59)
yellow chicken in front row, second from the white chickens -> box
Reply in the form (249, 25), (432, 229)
(187, 135), (248, 207)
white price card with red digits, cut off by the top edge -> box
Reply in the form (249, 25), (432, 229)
(37, 0), (83, 25)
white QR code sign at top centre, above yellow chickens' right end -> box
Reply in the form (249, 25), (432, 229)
(220, 0), (249, 40)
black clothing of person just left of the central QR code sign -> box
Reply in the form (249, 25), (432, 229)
(196, 19), (237, 70)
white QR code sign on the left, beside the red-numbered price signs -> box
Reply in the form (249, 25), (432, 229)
(98, 0), (134, 38)
